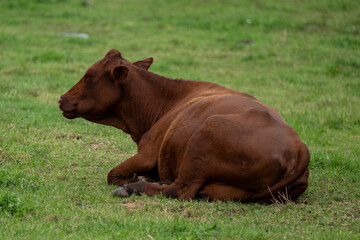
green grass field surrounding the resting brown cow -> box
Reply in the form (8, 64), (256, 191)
(0, 0), (360, 239)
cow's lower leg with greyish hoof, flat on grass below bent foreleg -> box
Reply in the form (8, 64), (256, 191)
(112, 181), (168, 197)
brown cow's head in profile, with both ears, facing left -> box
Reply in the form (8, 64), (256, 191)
(59, 49), (153, 123)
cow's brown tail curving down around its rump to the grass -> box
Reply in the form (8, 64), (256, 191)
(250, 144), (310, 202)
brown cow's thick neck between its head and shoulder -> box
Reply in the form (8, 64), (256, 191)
(118, 70), (199, 143)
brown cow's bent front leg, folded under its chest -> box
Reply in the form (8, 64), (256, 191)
(107, 153), (157, 186)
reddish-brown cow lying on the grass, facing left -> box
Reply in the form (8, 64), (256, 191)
(59, 49), (310, 202)
